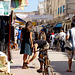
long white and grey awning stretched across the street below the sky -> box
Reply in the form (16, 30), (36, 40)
(16, 14), (53, 20)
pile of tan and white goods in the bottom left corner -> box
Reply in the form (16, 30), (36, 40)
(0, 51), (13, 75)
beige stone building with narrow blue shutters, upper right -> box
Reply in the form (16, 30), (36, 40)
(45, 0), (75, 30)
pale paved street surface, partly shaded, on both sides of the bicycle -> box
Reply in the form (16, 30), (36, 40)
(11, 50), (75, 75)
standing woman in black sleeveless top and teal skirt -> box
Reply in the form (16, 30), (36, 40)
(20, 21), (33, 69)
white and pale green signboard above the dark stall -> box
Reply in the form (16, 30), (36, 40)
(0, 1), (11, 16)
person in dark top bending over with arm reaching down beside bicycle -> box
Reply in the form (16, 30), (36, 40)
(29, 40), (49, 72)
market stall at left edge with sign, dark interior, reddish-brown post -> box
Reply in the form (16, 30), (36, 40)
(0, 0), (11, 73)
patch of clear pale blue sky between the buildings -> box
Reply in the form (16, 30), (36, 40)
(14, 0), (44, 12)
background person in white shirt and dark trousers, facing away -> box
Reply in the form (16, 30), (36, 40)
(56, 28), (66, 52)
